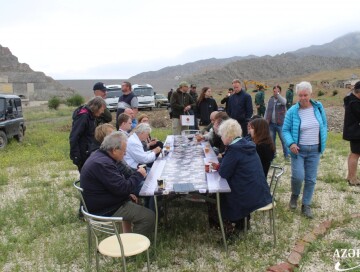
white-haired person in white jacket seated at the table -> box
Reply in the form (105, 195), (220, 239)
(124, 123), (161, 169)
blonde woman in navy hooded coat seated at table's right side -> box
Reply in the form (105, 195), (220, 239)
(218, 119), (272, 236)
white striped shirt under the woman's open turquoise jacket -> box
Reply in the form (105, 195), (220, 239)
(299, 106), (320, 145)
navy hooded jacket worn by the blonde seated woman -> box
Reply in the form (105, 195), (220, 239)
(219, 138), (272, 221)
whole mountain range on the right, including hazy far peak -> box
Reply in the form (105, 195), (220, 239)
(129, 32), (360, 93)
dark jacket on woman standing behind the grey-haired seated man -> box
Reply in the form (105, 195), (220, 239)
(69, 106), (95, 166)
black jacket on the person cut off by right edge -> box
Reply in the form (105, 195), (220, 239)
(343, 93), (360, 141)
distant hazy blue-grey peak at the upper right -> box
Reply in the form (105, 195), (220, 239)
(291, 32), (360, 58)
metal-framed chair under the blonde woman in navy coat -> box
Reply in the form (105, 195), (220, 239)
(245, 165), (284, 246)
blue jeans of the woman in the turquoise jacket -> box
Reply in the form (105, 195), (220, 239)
(291, 145), (320, 205)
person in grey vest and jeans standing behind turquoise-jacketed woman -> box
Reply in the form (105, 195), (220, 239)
(265, 85), (289, 160)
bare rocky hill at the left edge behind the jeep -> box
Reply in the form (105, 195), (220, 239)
(0, 45), (74, 100)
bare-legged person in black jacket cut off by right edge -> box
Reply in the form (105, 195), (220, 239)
(343, 81), (360, 186)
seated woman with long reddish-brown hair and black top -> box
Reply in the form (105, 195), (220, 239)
(248, 118), (275, 177)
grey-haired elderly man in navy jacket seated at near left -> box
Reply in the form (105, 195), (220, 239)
(80, 132), (155, 237)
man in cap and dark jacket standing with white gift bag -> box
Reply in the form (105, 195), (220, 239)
(170, 81), (195, 135)
